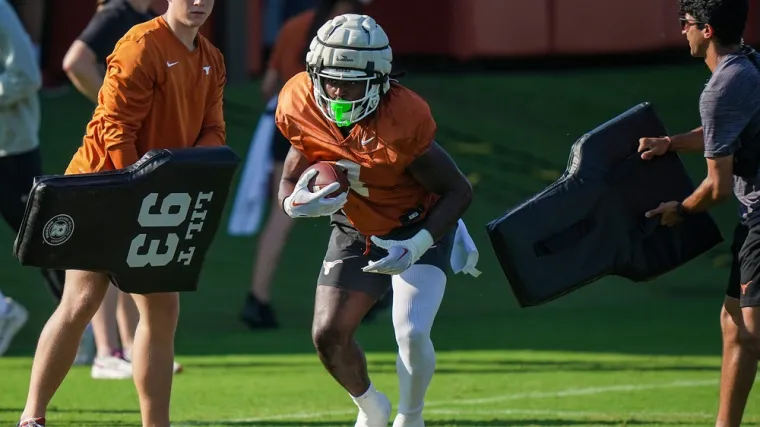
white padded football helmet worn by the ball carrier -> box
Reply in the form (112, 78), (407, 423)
(306, 14), (393, 126)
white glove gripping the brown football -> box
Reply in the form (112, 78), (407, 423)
(282, 169), (348, 218)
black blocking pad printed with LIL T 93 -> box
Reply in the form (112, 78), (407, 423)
(14, 147), (240, 294)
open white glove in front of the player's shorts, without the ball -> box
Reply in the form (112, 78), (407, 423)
(362, 228), (435, 275)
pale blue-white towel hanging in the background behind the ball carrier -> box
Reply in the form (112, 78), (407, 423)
(227, 95), (277, 236)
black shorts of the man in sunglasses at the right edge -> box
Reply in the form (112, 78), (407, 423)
(726, 224), (760, 307)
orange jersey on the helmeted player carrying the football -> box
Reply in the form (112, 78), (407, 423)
(275, 72), (438, 236)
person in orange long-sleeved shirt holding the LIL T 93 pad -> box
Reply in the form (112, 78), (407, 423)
(19, 0), (226, 427)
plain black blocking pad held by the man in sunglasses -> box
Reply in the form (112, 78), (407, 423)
(486, 103), (723, 307)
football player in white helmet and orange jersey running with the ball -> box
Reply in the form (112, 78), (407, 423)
(276, 14), (472, 427)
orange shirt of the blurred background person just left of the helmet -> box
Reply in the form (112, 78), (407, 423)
(267, 9), (316, 82)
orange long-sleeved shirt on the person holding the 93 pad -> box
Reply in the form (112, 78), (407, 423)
(66, 16), (226, 174)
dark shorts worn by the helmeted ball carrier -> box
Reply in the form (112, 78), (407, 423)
(317, 214), (456, 300)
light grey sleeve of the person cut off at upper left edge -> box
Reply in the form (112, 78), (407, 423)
(0, 1), (42, 107)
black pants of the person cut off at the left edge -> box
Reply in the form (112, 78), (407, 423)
(0, 148), (65, 302)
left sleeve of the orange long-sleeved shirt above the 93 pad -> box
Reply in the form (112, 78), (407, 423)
(99, 40), (155, 169)
